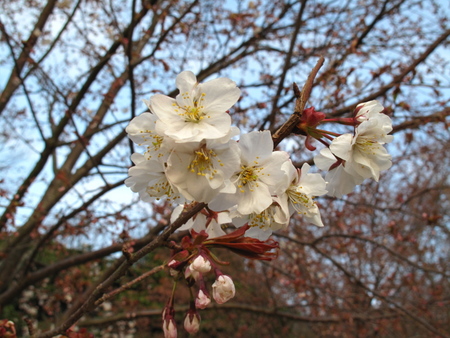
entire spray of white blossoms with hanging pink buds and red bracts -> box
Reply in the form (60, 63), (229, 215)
(125, 71), (392, 337)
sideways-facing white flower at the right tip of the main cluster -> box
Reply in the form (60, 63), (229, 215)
(280, 161), (327, 227)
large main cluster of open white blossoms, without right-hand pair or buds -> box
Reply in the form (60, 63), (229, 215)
(125, 71), (327, 240)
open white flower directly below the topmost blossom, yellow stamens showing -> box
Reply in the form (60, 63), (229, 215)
(166, 140), (240, 203)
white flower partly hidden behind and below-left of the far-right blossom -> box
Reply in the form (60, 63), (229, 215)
(314, 148), (364, 197)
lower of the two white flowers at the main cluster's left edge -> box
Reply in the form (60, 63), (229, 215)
(125, 153), (184, 203)
